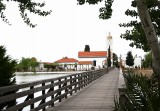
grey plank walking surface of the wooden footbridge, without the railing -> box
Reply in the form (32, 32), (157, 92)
(47, 69), (119, 111)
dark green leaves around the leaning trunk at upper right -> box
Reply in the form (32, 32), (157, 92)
(119, 0), (160, 52)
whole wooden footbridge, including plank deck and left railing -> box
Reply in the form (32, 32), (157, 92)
(0, 68), (119, 111)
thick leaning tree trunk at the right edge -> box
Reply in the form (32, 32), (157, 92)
(136, 0), (160, 111)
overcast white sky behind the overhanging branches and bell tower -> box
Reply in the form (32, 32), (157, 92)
(0, 0), (145, 62)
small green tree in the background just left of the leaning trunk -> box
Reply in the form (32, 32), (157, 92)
(142, 52), (152, 68)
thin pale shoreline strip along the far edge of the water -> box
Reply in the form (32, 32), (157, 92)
(14, 71), (85, 75)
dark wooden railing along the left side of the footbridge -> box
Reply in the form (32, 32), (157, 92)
(0, 68), (111, 111)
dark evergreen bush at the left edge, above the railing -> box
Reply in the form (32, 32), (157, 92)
(0, 46), (16, 87)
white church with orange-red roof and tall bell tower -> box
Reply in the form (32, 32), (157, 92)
(78, 33), (113, 70)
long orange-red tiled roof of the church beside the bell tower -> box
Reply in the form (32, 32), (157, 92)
(78, 51), (107, 58)
